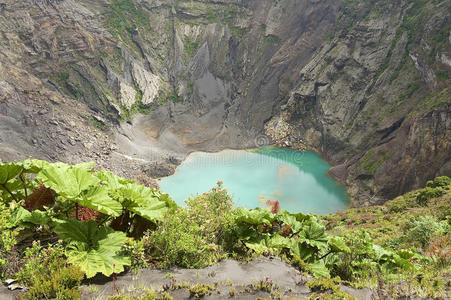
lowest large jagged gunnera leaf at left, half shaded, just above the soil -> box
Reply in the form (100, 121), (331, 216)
(55, 219), (131, 278)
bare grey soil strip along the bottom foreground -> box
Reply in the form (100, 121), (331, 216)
(0, 258), (375, 300)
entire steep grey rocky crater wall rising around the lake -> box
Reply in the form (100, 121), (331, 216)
(0, 0), (451, 205)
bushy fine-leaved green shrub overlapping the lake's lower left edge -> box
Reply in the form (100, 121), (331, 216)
(144, 183), (233, 268)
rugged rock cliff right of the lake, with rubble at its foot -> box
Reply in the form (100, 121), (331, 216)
(266, 1), (451, 205)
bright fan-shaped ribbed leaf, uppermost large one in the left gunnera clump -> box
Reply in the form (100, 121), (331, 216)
(37, 165), (100, 200)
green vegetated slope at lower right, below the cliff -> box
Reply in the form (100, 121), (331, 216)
(323, 176), (451, 297)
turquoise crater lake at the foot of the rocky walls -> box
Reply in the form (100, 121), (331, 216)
(159, 147), (349, 215)
